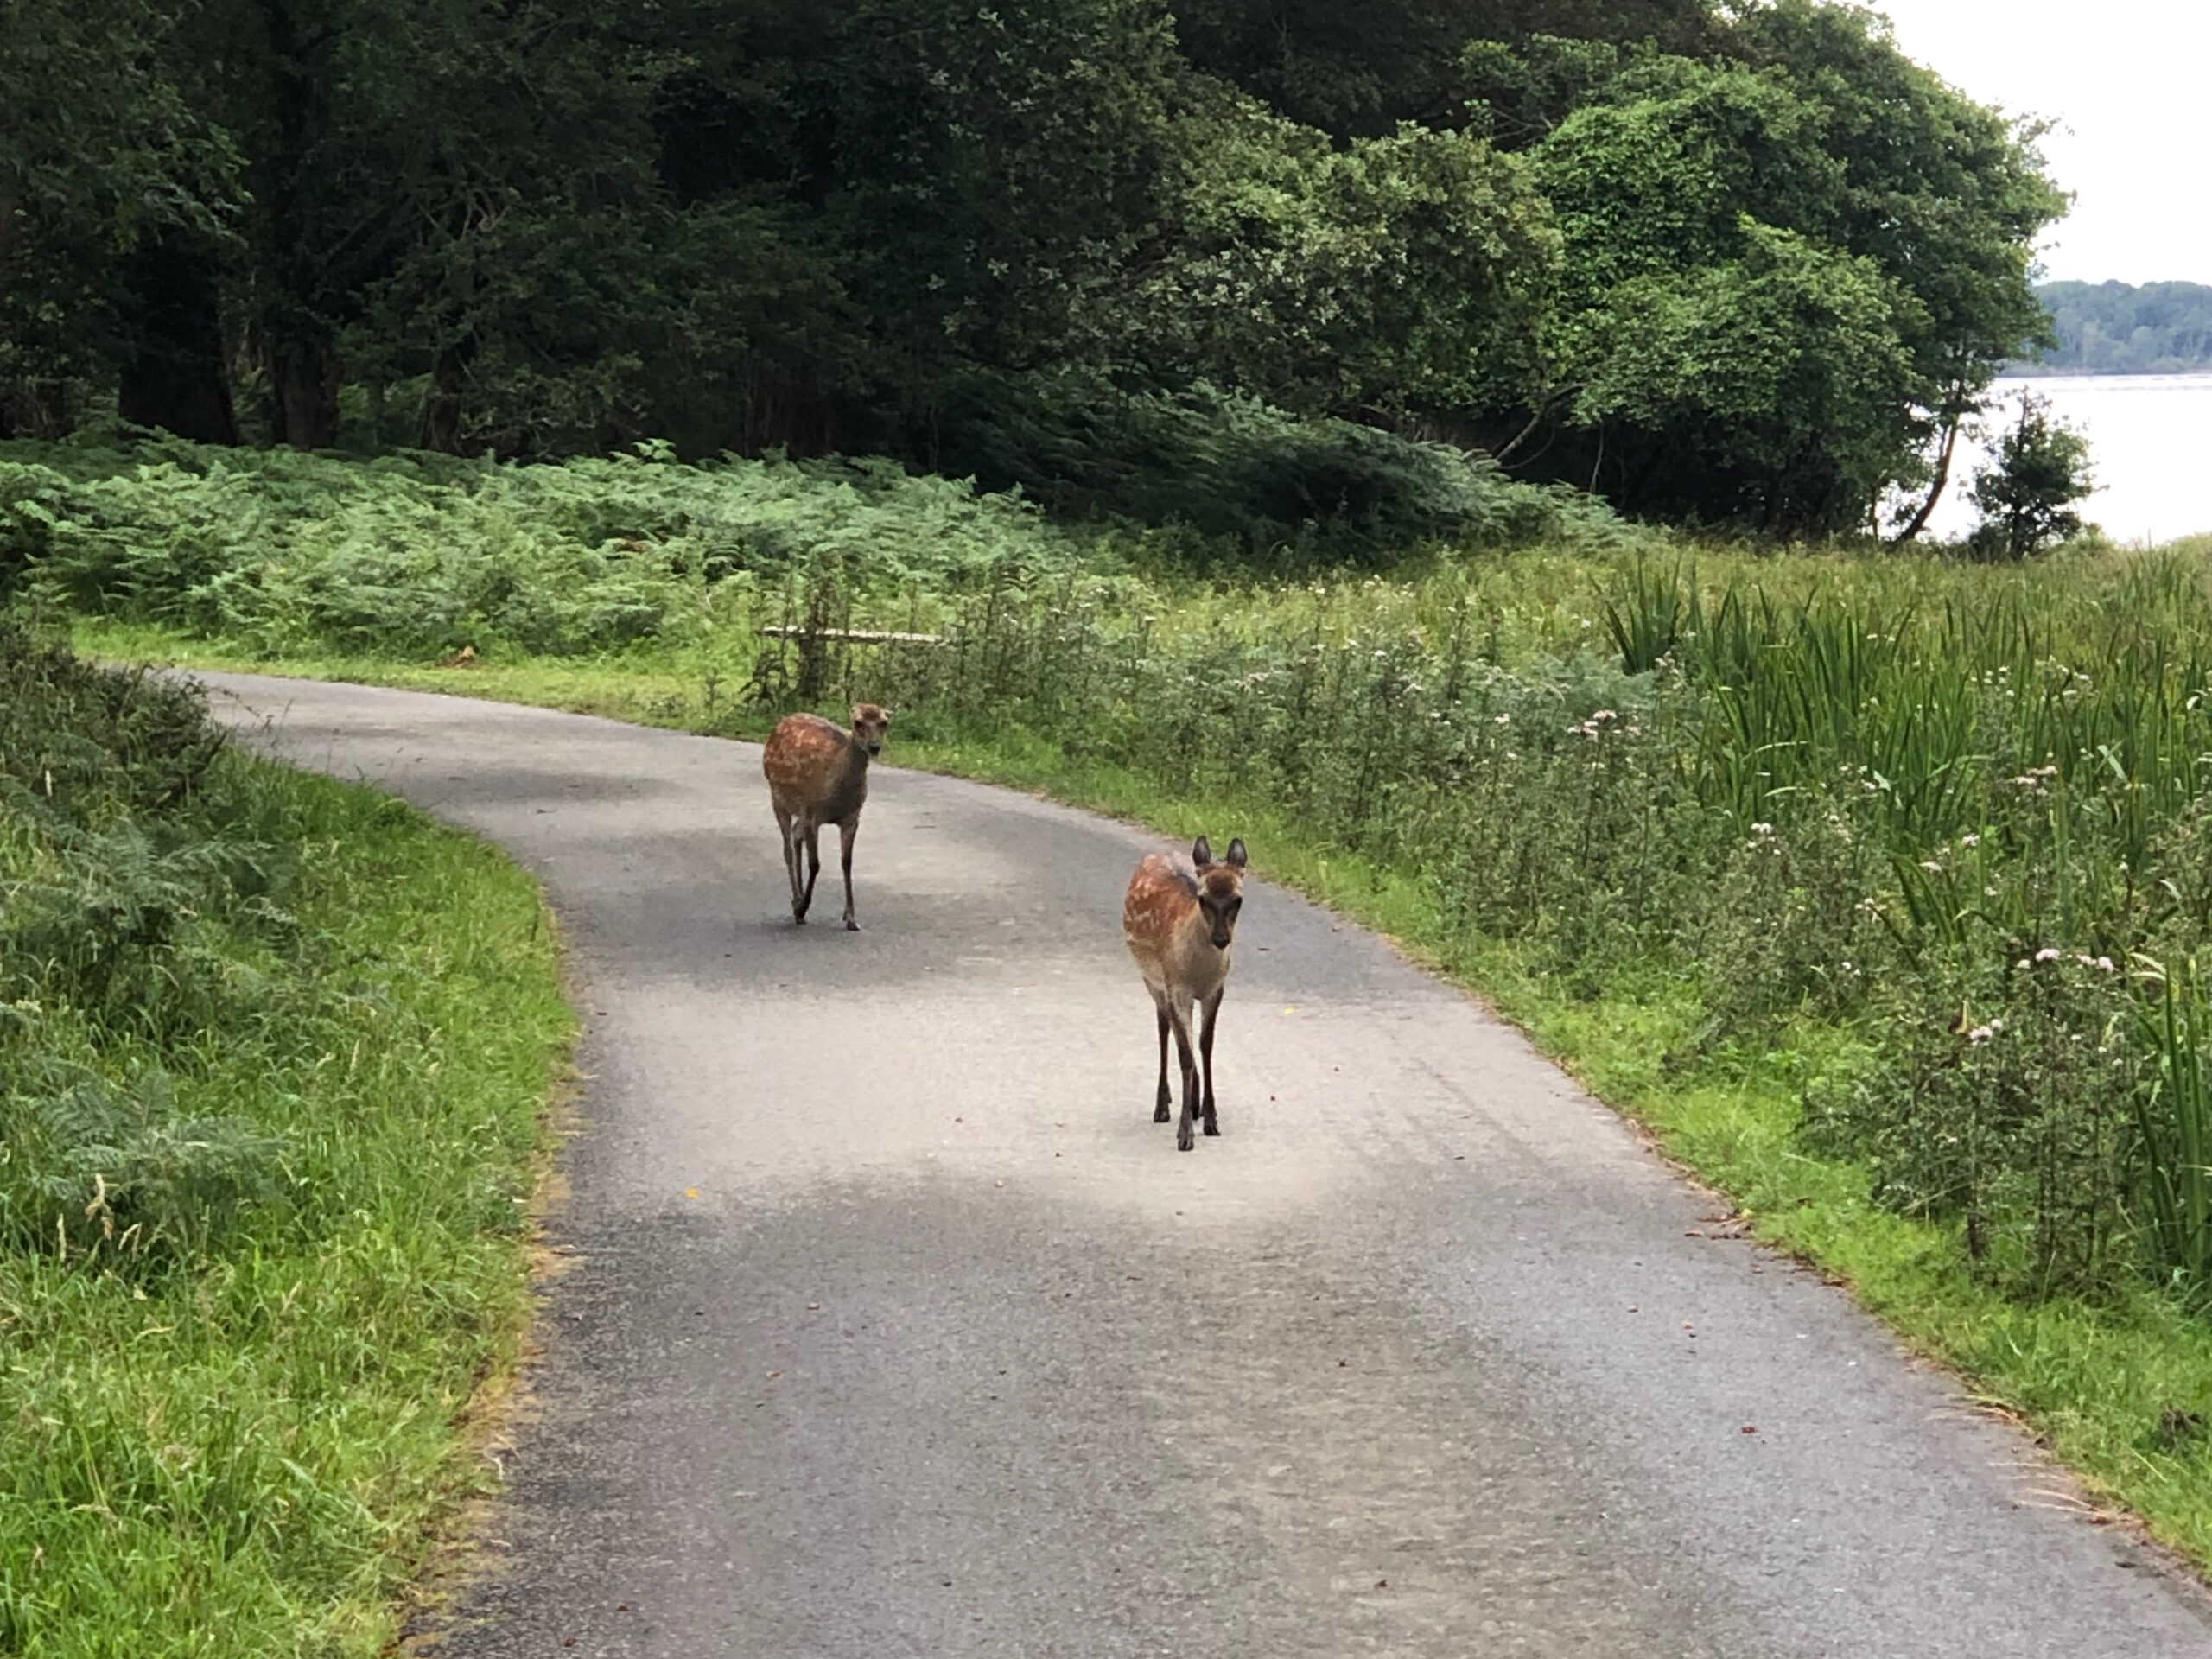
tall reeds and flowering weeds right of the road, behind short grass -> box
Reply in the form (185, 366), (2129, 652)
(831, 556), (2212, 1296)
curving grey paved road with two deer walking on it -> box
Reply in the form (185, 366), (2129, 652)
(213, 679), (2212, 1659)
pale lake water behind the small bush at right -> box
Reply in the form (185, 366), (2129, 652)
(1929, 374), (2212, 542)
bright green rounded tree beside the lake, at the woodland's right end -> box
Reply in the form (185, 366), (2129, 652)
(1524, 0), (2063, 533)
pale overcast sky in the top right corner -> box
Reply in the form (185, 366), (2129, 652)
(1872, 0), (2212, 283)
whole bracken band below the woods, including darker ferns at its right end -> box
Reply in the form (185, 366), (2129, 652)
(0, 435), (1626, 655)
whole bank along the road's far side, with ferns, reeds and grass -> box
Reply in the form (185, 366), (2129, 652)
(16, 435), (2212, 1564)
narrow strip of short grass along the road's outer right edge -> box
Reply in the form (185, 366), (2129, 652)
(78, 619), (2212, 1566)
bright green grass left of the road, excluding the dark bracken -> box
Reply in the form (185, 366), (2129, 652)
(0, 754), (573, 1659)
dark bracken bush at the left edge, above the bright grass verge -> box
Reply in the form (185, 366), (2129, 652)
(0, 624), (289, 1252)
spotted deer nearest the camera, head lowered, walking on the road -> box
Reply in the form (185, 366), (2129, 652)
(1122, 836), (1245, 1153)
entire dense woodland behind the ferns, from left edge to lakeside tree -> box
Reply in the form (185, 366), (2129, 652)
(0, 0), (2063, 533)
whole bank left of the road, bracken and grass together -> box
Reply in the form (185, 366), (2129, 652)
(0, 637), (569, 1659)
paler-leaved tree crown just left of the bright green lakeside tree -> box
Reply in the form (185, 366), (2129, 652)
(1095, 88), (1560, 427)
